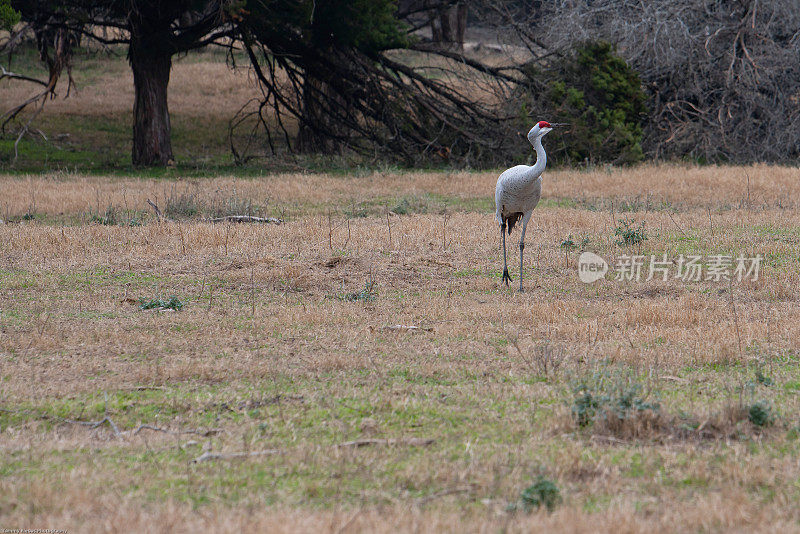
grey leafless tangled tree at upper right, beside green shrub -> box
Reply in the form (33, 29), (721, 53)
(532, 0), (800, 162)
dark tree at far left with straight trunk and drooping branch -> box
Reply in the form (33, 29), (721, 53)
(0, 0), (243, 165)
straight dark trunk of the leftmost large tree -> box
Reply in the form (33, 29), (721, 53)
(129, 40), (172, 166)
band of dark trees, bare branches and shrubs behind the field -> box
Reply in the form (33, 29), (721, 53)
(0, 0), (800, 167)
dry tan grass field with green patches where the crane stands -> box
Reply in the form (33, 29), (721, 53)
(0, 165), (800, 532)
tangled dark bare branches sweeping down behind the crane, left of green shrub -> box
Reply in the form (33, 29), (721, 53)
(231, 7), (519, 168)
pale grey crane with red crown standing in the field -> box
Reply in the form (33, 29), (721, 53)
(494, 121), (553, 291)
